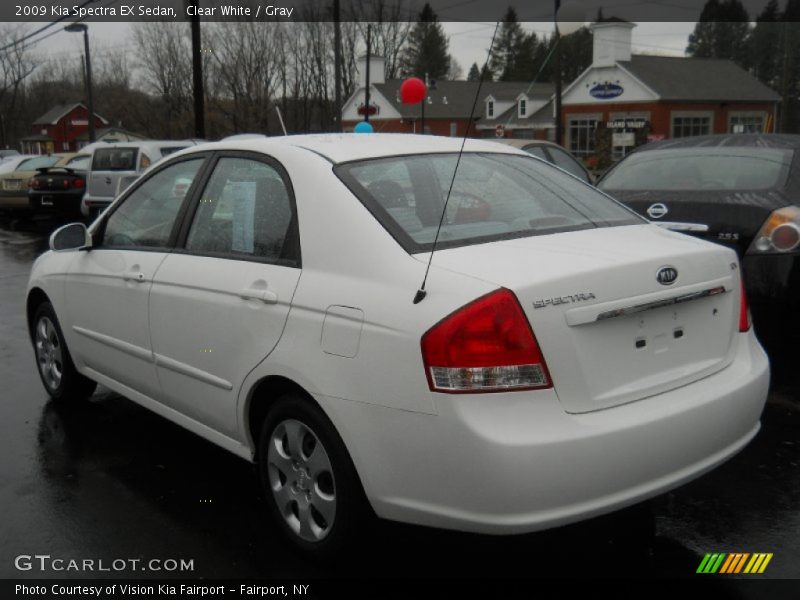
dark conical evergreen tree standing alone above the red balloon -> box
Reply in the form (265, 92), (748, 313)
(400, 3), (450, 79)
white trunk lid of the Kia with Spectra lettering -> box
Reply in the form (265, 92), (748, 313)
(418, 225), (739, 413)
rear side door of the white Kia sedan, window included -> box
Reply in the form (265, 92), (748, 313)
(150, 153), (300, 436)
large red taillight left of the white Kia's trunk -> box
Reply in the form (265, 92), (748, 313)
(422, 289), (552, 393)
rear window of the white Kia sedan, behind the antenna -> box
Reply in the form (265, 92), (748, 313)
(335, 153), (644, 252)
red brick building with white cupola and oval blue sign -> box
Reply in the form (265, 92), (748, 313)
(562, 19), (780, 165)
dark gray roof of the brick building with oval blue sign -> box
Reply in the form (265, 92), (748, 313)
(619, 54), (780, 102)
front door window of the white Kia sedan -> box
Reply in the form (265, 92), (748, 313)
(100, 158), (205, 248)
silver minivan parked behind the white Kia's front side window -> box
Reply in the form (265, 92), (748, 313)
(81, 140), (197, 217)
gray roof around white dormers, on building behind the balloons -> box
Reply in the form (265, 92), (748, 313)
(374, 79), (554, 119)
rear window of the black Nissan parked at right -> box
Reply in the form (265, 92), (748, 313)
(599, 147), (793, 191)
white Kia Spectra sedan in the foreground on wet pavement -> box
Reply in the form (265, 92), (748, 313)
(27, 134), (769, 553)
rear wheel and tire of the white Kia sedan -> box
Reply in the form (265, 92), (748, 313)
(258, 394), (372, 560)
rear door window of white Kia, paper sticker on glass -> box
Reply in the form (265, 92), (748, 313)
(186, 157), (296, 261)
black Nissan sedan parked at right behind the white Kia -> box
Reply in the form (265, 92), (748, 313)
(598, 134), (800, 346)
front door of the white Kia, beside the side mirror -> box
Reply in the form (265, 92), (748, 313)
(65, 156), (205, 398)
